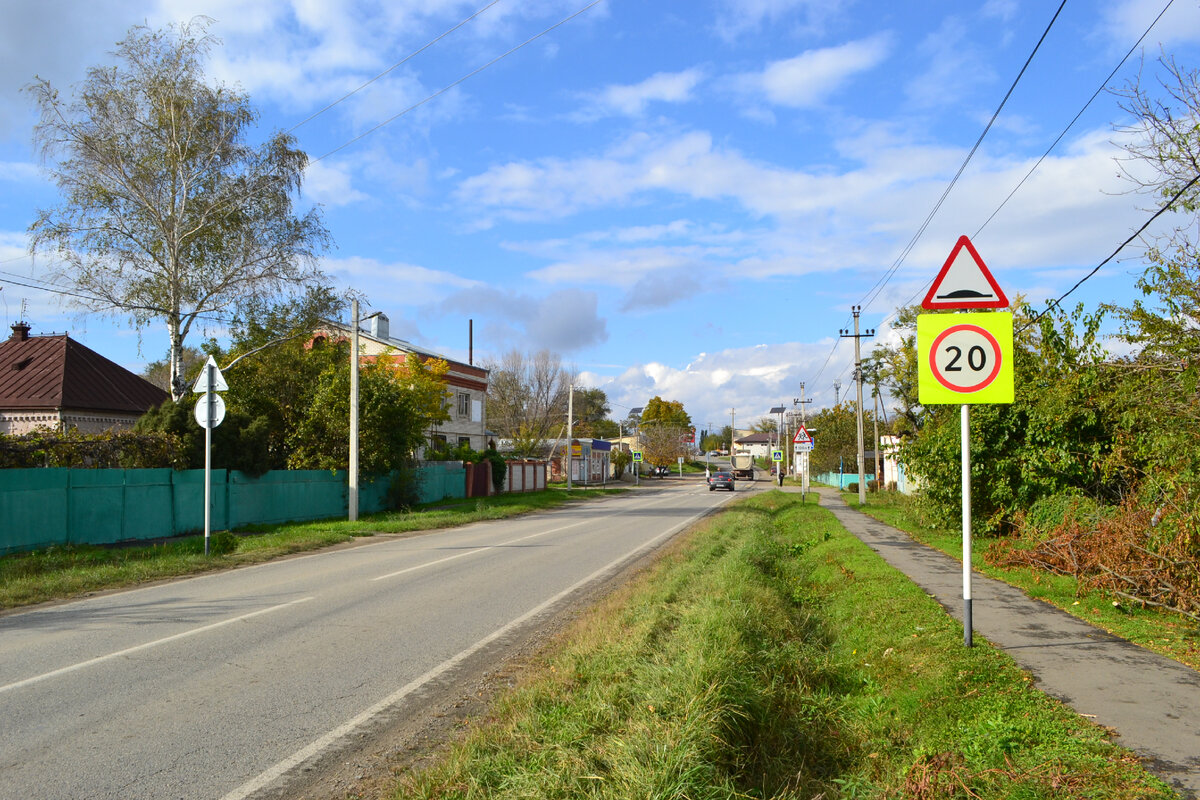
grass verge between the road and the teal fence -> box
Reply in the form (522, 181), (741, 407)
(0, 489), (624, 608)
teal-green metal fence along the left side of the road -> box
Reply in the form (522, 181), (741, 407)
(0, 462), (466, 554)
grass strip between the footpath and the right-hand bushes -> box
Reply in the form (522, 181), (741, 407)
(842, 492), (1200, 669)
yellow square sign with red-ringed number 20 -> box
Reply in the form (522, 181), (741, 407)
(917, 312), (1013, 405)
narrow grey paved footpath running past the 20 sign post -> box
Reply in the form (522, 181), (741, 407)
(817, 488), (1200, 799)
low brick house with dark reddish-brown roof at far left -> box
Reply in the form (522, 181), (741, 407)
(0, 323), (168, 434)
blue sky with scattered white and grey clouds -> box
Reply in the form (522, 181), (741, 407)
(0, 0), (1200, 427)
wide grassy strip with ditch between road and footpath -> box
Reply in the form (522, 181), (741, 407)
(391, 492), (1175, 800)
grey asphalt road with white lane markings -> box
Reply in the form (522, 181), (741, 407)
(0, 479), (740, 800)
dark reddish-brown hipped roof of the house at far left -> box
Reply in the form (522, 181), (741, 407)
(0, 327), (167, 413)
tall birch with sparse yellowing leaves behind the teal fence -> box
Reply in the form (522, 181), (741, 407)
(28, 18), (330, 398)
